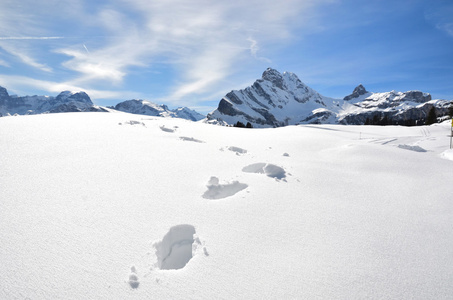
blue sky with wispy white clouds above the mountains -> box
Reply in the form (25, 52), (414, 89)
(0, 0), (453, 113)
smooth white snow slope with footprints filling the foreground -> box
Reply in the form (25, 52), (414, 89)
(0, 113), (453, 299)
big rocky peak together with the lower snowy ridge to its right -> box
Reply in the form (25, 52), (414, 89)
(207, 68), (452, 127)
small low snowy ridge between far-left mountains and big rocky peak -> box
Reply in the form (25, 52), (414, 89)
(114, 99), (205, 121)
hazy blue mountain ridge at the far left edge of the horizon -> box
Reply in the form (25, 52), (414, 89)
(0, 87), (106, 116)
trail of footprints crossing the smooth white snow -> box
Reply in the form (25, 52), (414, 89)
(127, 123), (290, 289)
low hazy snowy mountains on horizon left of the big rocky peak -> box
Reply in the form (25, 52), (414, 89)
(0, 87), (205, 121)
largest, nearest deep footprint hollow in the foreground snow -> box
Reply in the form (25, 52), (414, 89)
(154, 224), (195, 270)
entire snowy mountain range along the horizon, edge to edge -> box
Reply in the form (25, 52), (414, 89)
(0, 68), (453, 127)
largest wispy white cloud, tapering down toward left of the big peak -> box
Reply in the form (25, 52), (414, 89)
(49, 0), (330, 102)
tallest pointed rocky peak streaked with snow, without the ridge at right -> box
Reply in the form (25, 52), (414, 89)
(208, 68), (333, 127)
